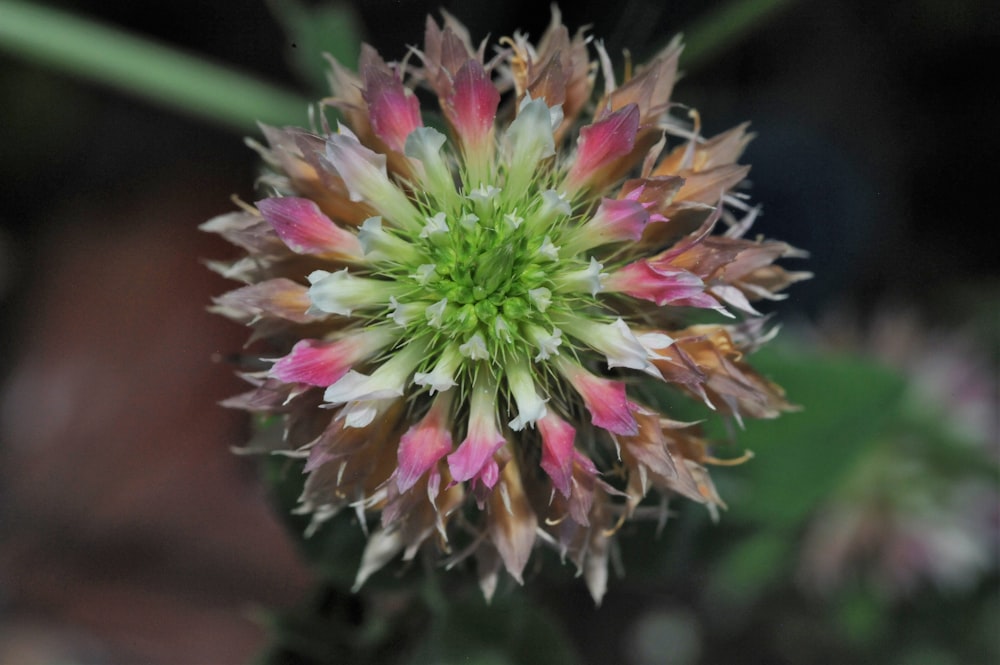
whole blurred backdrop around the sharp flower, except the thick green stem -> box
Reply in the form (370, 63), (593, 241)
(0, 0), (1000, 665)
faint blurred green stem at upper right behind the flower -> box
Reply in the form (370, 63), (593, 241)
(682, 0), (792, 70)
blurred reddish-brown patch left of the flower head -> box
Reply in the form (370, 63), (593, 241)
(0, 172), (309, 663)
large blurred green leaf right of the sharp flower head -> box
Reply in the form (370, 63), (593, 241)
(712, 349), (905, 602)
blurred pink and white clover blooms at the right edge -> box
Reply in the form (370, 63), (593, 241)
(799, 308), (1000, 597)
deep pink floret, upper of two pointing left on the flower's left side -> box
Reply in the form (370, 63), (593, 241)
(257, 196), (362, 256)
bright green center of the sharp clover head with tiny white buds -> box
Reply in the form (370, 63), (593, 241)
(360, 129), (601, 396)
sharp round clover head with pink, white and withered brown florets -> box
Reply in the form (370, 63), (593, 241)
(204, 10), (807, 602)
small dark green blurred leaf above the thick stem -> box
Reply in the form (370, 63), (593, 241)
(268, 0), (362, 93)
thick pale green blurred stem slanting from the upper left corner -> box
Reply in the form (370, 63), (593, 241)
(0, 0), (308, 132)
